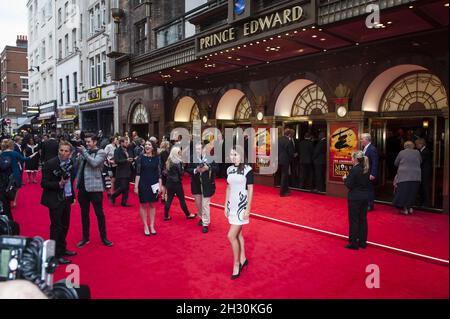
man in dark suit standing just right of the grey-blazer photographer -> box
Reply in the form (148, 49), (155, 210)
(109, 137), (134, 207)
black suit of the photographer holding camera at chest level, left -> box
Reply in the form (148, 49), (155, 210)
(41, 157), (75, 257)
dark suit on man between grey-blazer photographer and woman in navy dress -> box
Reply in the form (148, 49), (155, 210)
(111, 147), (131, 205)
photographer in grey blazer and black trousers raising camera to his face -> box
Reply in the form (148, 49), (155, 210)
(77, 135), (112, 248)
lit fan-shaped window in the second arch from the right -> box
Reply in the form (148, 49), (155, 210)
(292, 84), (328, 116)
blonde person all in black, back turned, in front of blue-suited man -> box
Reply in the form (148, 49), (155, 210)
(343, 151), (369, 250)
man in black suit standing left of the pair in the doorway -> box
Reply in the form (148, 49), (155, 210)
(278, 129), (295, 197)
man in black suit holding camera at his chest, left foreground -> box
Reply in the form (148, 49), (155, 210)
(41, 142), (76, 264)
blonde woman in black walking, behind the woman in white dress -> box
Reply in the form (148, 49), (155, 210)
(164, 146), (197, 221)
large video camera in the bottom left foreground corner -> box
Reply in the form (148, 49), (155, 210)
(0, 236), (90, 299)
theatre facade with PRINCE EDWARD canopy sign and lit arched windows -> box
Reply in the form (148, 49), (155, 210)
(113, 0), (449, 212)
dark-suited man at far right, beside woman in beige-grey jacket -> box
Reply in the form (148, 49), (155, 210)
(416, 138), (433, 207)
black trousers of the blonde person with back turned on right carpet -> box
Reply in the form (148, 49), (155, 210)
(348, 200), (368, 246)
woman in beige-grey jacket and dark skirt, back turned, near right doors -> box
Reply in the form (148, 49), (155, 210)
(393, 141), (422, 215)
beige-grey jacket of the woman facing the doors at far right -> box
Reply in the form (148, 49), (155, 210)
(394, 149), (422, 183)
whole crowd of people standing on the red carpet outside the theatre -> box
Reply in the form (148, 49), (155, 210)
(0, 129), (431, 279)
